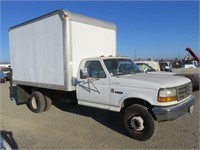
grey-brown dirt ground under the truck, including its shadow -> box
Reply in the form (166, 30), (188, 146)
(0, 82), (200, 149)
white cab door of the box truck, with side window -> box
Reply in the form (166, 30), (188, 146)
(76, 60), (110, 109)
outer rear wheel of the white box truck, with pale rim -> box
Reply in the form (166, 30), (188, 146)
(27, 91), (45, 113)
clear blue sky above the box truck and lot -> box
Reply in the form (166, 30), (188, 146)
(0, 0), (200, 61)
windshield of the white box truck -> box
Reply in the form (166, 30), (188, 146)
(104, 59), (141, 76)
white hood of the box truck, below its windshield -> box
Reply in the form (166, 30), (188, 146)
(111, 73), (190, 89)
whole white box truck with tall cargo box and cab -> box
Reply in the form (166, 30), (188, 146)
(9, 10), (195, 140)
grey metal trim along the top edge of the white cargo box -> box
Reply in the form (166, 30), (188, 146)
(9, 9), (116, 31)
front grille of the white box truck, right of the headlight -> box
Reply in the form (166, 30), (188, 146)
(177, 83), (192, 101)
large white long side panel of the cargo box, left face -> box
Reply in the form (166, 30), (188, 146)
(9, 14), (64, 87)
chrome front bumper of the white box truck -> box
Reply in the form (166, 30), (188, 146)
(152, 96), (195, 121)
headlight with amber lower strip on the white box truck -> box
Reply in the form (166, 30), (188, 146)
(158, 88), (177, 102)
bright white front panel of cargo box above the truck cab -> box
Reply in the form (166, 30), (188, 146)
(71, 21), (116, 77)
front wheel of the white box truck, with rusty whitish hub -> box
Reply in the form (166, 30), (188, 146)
(123, 104), (157, 141)
